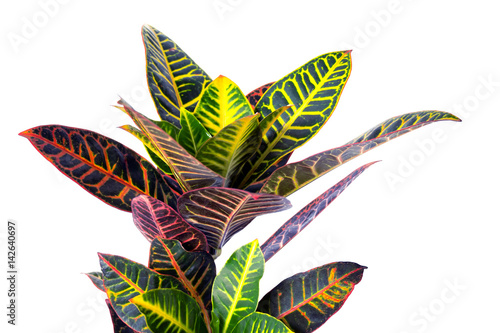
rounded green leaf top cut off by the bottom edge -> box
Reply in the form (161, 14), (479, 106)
(231, 312), (293, 333)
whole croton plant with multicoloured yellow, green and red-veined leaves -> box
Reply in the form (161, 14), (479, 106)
(20, 26), (459, 333)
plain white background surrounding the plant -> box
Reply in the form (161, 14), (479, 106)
(0, 0), (500, 333)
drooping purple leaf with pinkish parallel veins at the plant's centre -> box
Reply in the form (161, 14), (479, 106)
(178, 187), (290, 250)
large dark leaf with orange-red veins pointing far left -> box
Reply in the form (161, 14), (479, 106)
(20, 125), (176, 211)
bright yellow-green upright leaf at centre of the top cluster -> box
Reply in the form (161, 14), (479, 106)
(194, 75), (254, 135)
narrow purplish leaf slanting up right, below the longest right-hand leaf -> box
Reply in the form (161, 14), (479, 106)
(261, 162), (375, 261)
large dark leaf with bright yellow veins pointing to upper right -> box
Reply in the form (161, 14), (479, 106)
(239, 51), (351, 188)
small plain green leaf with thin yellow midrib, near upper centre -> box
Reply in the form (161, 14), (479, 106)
(177, 109), (212, 156)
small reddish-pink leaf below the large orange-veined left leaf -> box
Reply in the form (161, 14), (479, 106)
(132, 195), (208, 251)
